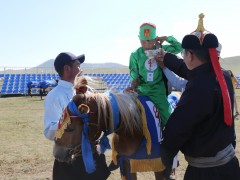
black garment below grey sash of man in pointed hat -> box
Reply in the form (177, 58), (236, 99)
(184, 157), (240, 180)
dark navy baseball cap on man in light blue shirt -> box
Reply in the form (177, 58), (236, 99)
(54, 52), (85, 73)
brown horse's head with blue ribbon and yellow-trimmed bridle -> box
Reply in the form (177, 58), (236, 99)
(53, 94), (101, 163)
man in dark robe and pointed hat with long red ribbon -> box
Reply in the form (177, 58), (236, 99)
(161, 14), (240, 180)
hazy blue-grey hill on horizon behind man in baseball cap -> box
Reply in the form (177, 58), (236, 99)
(37, 59), (127, 69)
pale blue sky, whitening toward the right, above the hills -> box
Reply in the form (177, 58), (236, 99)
(0, 0), (240, 67)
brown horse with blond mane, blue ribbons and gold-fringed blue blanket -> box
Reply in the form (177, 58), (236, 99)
(54, 76), (180, 180)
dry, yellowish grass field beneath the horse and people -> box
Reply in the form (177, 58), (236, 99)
(0, 89), (240, 180)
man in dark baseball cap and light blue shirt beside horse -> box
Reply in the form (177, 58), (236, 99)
(44, 52), (110, 180)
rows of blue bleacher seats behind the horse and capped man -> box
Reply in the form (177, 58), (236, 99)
(0, 73), (130, 96)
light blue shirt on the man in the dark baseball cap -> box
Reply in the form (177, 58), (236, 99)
(44, 80), (75, 141)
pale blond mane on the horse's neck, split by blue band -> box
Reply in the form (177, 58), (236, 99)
(90, 91), (142, 135)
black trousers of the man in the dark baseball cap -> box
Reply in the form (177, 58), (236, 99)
(53, 154), (110, 180)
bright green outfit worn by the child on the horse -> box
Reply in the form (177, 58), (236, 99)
(129, 36), (182, 126)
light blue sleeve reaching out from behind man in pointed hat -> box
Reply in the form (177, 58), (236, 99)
(162, 67), (188, 92)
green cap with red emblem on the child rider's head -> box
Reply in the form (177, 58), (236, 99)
(138, 23), (156, 41)
